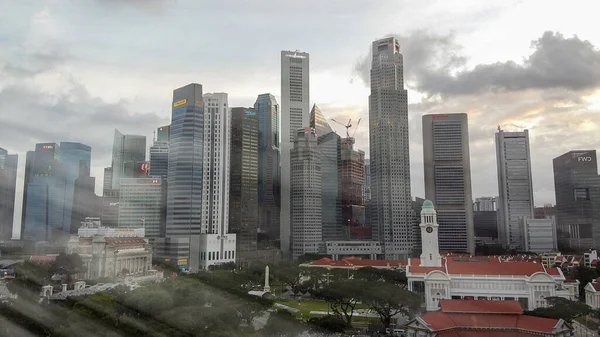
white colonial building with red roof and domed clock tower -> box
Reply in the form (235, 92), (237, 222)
(406, 200), (578, 311)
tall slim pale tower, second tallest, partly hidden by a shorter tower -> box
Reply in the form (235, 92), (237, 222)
(280, 50), (310, 256)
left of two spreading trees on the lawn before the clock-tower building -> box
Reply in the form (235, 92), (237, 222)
(314, 279), (367, 325)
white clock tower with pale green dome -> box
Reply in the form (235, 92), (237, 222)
(420, 200), (442, 267)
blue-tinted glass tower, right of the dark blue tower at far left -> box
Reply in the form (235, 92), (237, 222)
(59, 142), (92, 233)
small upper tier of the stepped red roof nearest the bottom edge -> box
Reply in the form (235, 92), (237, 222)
(440, 300), (523, 315)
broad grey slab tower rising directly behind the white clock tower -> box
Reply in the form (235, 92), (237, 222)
(423, 113), (475, 254)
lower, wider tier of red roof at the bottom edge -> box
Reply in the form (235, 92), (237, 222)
(421, 311), (558, 333)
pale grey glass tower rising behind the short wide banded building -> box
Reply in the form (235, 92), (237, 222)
(111, 129), (146, 190)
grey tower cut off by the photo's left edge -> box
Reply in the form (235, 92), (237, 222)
(0, 147), (18, 241)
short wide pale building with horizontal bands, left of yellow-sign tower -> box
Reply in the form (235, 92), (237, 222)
(119, 177), (165, 243)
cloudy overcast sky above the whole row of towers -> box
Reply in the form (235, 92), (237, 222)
(0, 0), (600, 234)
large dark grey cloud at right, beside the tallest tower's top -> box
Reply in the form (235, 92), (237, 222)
(354, 31), (600, 96)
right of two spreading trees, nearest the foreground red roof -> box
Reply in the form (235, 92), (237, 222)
(362, 281), (421, 327)
